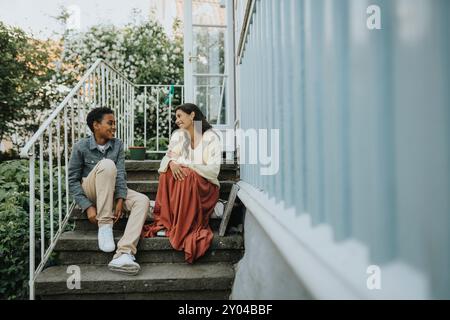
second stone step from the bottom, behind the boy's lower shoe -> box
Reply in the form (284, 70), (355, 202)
(55, 231), (244, 265)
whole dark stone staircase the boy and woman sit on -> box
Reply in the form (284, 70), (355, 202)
(35, 161), (244, 300)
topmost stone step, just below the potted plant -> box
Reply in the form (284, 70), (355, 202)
(125, 160), (239, 181)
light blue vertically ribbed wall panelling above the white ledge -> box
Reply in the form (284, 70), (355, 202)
(238, 0), (450, 298)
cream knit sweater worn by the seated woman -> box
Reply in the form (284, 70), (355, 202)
(158, 129), (222, 187)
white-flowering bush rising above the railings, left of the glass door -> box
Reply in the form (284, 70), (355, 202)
(64, 21), (183, 84)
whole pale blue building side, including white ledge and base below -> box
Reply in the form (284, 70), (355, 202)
(233, 0), (450, 299)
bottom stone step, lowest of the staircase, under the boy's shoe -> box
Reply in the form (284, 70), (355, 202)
(35, 263), (234, 299)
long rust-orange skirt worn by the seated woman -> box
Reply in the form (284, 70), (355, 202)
(142, 168), (219, 263)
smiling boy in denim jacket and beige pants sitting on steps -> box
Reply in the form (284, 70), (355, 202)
(69, 108), (150, 275)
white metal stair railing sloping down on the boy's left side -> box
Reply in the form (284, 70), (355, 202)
(20, 59), (141, 299)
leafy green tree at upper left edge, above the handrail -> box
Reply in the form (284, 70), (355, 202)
(0, 22), (59, 140)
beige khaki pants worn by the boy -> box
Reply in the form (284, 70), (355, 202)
(81, 159), (150, 259)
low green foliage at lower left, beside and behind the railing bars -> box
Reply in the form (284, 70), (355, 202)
(0, 160), (69, 299)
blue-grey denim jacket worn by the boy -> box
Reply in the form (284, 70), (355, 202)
(69, 136), (127, 211)
